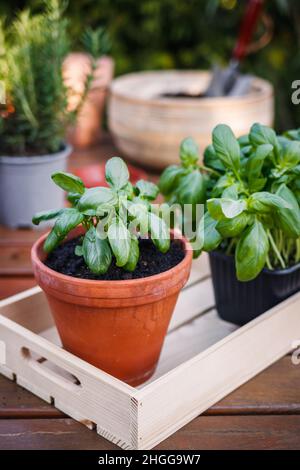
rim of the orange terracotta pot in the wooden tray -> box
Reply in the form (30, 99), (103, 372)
(31, 227), (193, 288)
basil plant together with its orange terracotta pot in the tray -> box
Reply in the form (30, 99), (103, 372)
(32, 157), (192, 385)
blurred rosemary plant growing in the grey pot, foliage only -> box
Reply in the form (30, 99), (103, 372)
(0, 0), (108, 155)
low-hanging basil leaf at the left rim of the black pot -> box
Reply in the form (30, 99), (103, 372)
(196, 212), (222, 252)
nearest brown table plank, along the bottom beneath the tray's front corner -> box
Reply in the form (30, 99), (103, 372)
(0, 415), (300, 451)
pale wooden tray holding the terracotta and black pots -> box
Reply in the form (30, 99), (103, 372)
(0, 255), (300, 449)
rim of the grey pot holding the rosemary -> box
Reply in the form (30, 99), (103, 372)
(0, 142), (73, 165)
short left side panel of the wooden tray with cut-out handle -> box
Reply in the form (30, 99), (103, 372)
(0, 312), (136, 449)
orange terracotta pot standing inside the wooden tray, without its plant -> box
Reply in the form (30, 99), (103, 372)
(31, 228), (192, 386)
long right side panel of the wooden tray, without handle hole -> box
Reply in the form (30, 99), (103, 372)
(138, 293), (300, 449)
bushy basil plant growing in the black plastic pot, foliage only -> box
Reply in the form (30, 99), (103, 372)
(160, 124), (300, 281)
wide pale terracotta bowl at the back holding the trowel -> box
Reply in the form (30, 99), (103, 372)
(108, 70), (274, 169)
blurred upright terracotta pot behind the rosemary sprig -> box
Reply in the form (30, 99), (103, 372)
(63, 52), (114, 148)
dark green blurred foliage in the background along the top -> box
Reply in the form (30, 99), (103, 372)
(0, 0), (300, 130)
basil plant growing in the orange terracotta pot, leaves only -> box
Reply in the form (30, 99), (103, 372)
(32, 157), (170, 274)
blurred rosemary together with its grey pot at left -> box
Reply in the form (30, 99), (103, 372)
(0, 0), (103, 227)
